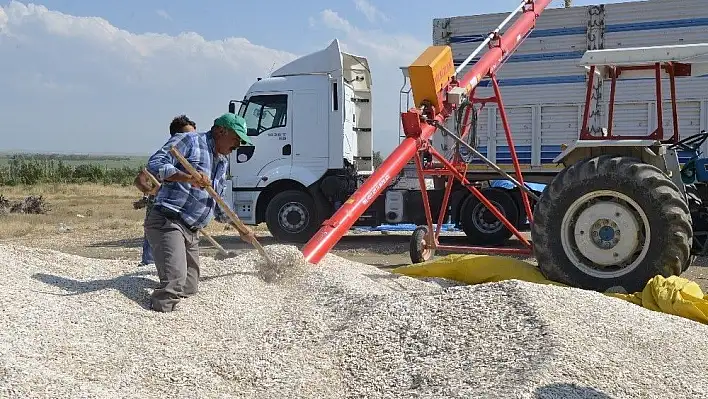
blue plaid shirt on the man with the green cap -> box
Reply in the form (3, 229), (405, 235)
(147, 131), (229, 228)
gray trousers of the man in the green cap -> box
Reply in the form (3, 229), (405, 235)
(145, 208), (199, 312)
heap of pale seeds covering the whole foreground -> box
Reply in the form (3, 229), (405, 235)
(0, 245), (708, 398)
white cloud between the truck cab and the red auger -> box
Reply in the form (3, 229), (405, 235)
(319, 9), (429, 154)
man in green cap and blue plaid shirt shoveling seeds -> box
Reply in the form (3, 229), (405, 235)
(145, 113), (254, 312)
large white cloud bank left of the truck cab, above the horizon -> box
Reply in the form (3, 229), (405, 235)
(0, 1), (295, 153)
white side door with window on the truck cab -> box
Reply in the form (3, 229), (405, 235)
(231, 92), (292, 191)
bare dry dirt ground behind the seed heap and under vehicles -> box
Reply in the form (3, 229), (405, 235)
(0, 184), (708, 292)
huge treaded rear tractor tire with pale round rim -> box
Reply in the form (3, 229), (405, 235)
(531, 155), (693, 293)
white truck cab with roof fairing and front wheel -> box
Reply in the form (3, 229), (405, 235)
(224, 39), (373, 242)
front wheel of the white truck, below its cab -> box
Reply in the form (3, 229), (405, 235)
(266, 190), (320, 243)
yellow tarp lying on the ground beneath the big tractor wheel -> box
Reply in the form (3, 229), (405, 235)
(392, 254), (708, 324)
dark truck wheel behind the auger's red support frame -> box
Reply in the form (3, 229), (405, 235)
(460, 188), (519, 246)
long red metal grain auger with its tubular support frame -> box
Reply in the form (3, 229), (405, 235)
(302, 0), (551, 264)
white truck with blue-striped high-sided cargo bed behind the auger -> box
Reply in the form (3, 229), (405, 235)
(227, 0), (708, 245)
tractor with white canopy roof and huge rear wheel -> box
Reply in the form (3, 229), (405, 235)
(531, 44), (708, 292)
